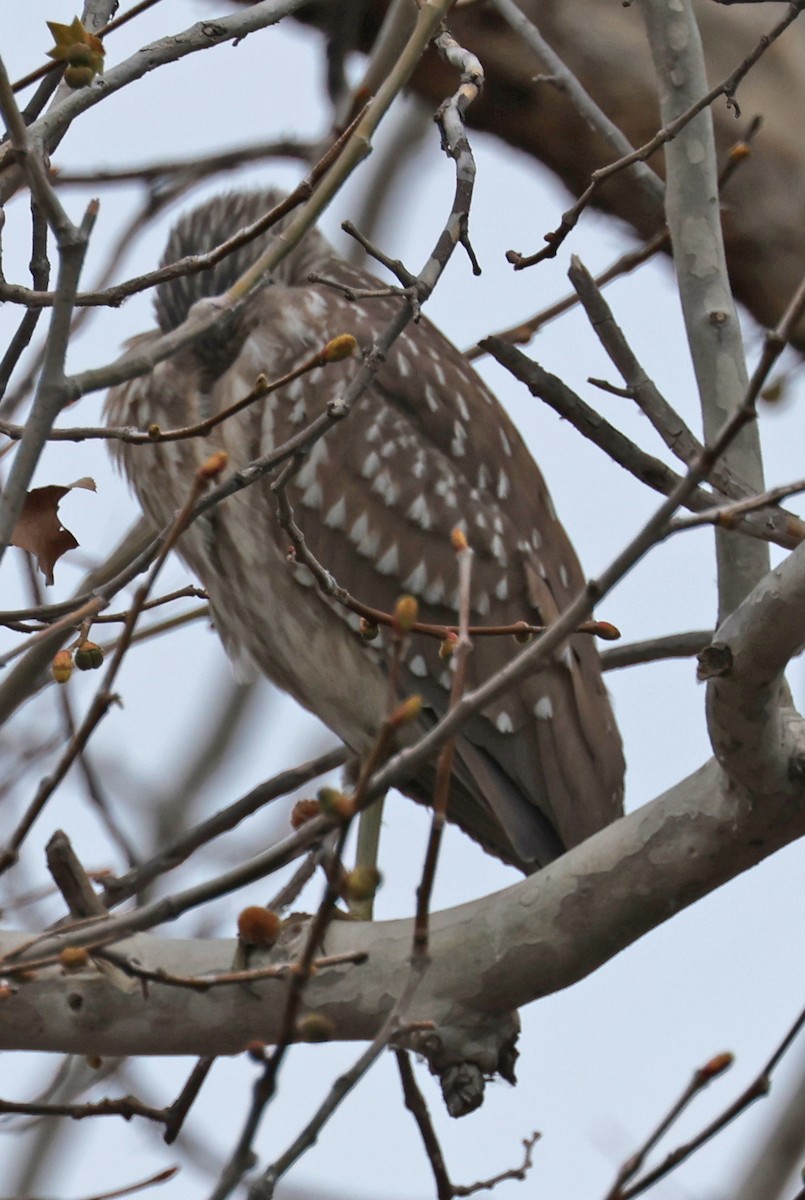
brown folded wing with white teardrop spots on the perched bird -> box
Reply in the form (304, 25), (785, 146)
(196, 259), (623, 865)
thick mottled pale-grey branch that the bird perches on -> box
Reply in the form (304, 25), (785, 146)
(0, 744), (805, 1061)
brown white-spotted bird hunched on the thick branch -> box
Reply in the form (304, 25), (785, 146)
(106, 188), (624, 874)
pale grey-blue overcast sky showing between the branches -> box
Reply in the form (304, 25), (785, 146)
(0, 0), (805, 1200)
